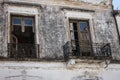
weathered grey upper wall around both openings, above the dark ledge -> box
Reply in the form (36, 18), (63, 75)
(0, 0), (120, 59)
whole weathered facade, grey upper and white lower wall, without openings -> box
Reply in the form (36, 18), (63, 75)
(0, 0), (120, 80)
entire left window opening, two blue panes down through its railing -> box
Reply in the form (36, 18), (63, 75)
(9, 16), (38, 58)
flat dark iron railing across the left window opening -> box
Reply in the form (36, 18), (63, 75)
(8, 43), (39, 58)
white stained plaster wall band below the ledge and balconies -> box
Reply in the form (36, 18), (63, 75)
(0, 61), (120, 80)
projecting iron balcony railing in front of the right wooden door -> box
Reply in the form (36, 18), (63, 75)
(63, 42), (111, 60)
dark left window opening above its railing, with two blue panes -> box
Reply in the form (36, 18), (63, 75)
(11, 16), (34, 44)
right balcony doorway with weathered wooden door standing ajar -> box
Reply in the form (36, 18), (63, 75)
(69, 20), (92, 57)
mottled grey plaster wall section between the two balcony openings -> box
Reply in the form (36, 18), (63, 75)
(40, 5), (66, 59)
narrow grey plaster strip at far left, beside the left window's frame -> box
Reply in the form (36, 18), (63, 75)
(0, 3), (7, 56)
